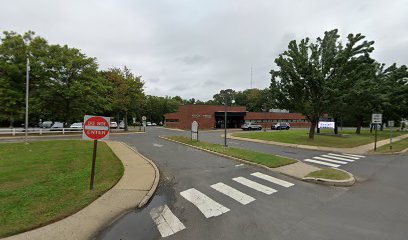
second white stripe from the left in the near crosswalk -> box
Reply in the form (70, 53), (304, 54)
(180, 188), (229, 218)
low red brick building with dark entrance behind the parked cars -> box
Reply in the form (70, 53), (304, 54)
(164, 105), (310, 129)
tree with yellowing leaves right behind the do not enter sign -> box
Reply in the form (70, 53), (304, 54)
(103, 66), (144, 131)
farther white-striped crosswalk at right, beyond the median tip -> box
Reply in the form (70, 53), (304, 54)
(304, 153), (365, 168)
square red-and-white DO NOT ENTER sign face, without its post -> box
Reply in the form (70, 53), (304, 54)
(82, 115), (109, 140)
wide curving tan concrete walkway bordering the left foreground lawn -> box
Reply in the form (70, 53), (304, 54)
(4, 141), (159, 240)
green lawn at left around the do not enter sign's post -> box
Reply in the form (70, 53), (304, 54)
(0, 140), (123, 237)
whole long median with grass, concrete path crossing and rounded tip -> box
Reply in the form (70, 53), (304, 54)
(161, 136), (355, 186)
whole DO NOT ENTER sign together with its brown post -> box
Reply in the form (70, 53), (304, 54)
(82, 115), (110, 190)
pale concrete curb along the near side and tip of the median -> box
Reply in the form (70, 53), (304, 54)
(159, 136), (355, 187)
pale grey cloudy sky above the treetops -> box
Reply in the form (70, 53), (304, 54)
(0, 0), (408, 100)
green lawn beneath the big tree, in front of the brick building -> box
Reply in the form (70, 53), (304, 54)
(232, 129), (404, 148)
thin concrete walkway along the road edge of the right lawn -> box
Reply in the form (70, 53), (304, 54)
(227, 134), (408, 154)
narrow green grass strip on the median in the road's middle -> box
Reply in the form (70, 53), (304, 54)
(168, 136), (296, 168)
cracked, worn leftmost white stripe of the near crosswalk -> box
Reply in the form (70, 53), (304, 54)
(150, 205), (186, 237)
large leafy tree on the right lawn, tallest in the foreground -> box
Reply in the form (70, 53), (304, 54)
(270, 29), (374, 139)
